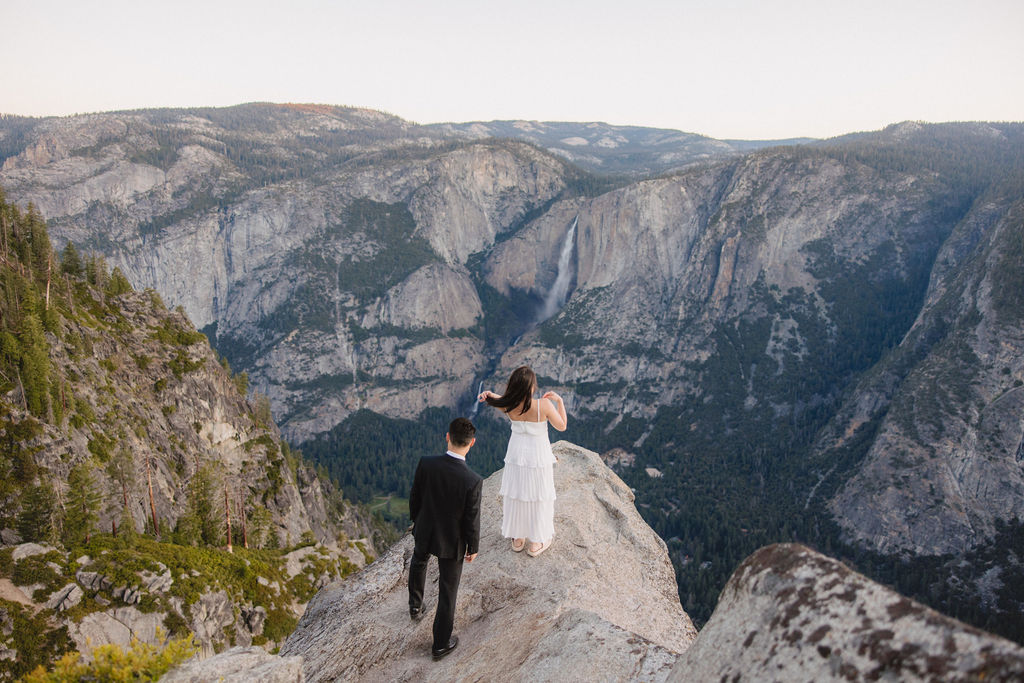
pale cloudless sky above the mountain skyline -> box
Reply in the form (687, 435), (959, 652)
(0, 0), (1024, 139)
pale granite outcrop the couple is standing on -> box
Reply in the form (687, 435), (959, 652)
(281, 441), (696, 681)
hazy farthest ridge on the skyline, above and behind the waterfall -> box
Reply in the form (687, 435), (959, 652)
(428, 121), (811, 177)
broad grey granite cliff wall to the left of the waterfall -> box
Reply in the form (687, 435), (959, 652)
(0, 113), (565, 441)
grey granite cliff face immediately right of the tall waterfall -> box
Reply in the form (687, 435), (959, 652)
(488, 148), (951, 417)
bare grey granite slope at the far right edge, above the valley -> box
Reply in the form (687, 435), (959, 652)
(819, 194), (1024, 554)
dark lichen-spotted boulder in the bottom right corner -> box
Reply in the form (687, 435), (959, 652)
(668, 545), (1024, 682)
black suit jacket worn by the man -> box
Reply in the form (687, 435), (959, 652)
(409, 455), (483, 559)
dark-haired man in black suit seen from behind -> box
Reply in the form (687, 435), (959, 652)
(409, 418), (483, 660)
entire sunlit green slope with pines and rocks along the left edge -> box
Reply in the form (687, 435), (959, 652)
(0, 195), (375, 680)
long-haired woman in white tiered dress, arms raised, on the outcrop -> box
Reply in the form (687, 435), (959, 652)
(477, 366), (567, 557)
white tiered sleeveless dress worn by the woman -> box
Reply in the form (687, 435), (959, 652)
(500, 403), (555, 543)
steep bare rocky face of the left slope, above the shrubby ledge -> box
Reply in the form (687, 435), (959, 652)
(4, 292), (368, 545)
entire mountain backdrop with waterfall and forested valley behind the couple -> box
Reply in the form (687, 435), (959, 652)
(0, 104), (1024, 639)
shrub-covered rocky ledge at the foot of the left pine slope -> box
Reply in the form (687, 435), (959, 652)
(0, 544), (366, 663)
